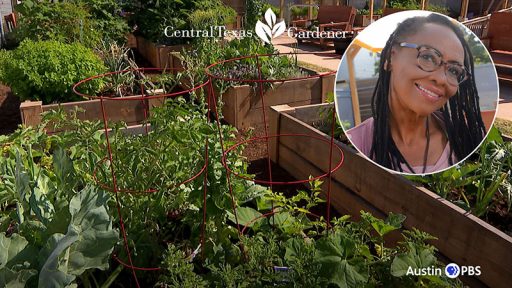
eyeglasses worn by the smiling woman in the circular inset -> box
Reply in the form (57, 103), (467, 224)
(400, 42), (471, 86)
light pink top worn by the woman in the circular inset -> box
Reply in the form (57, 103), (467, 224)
(345, 117), (457, 174)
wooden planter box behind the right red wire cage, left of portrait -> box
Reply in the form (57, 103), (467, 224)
(222, 71), (335, 129)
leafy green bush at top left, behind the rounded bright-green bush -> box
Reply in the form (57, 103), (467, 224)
(16, 0), (128, 48)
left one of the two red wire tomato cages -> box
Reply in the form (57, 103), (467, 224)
(73, 68), (212, 287)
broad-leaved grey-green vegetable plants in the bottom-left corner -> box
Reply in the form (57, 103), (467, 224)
(0, 128), (118, 287)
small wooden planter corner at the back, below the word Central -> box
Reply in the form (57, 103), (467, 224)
(137, 36), (189, 68)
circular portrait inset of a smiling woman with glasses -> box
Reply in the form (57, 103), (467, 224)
(335, 11), (499, 174)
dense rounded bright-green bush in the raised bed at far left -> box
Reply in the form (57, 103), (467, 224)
(0, 40), (106, 104)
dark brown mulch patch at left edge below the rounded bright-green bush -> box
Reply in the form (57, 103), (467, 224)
(0, 84), (21, 135)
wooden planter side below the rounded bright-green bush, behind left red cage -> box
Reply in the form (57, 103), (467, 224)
(20, 96), (164, 132)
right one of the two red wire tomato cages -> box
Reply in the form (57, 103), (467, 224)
(206, 53), (343, 233)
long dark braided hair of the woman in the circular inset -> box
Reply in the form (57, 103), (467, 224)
(370, 13), (486, 172)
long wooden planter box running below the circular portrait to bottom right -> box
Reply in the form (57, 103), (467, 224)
(270, 104), (512, 287)
